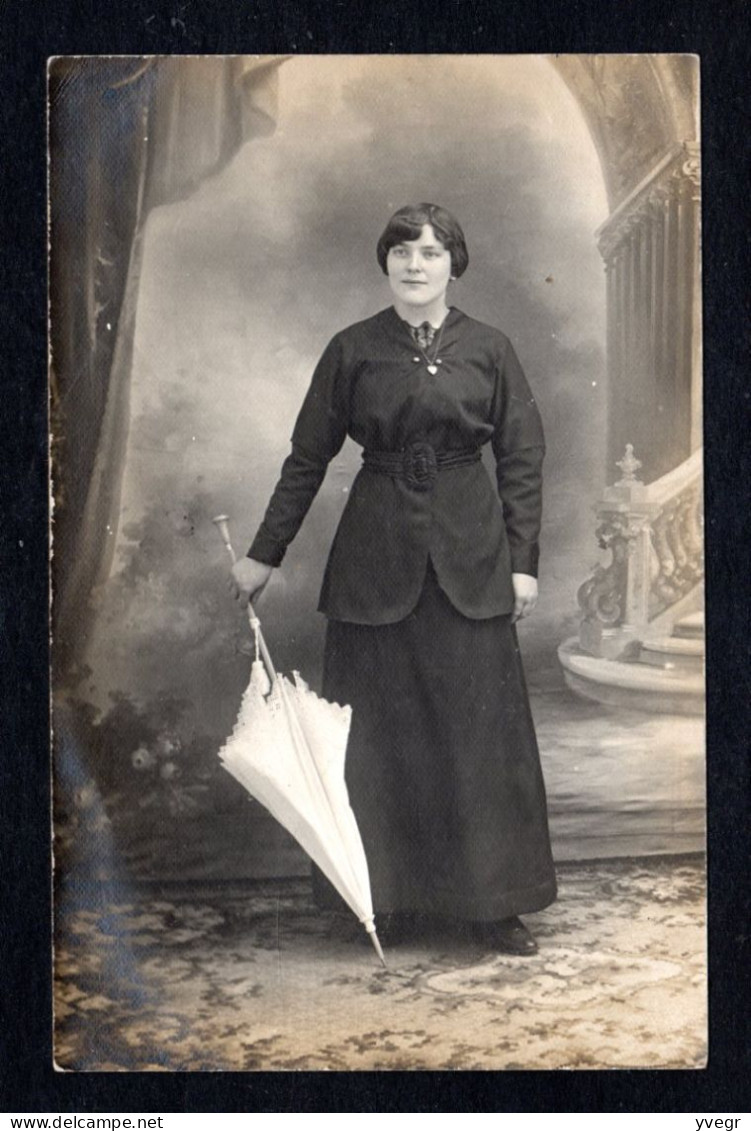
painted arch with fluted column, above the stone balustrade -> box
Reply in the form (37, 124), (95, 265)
(552, 54), (701, 482)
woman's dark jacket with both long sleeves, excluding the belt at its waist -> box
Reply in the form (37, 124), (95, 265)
(248, 308), (544, 624)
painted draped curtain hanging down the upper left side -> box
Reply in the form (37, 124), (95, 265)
(49, 57), (284, 677)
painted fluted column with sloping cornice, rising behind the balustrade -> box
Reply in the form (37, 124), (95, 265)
(598, 143), (701, 482)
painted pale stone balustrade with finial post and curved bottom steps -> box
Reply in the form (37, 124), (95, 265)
(558, 446), (705, 715)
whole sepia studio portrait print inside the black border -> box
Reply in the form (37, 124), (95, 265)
(48, 54), (708, 1072)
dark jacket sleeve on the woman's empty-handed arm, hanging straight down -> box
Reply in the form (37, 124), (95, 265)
(492, 342), (545, 577)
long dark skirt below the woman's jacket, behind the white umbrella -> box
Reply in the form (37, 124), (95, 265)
(316, 560), (555, 921)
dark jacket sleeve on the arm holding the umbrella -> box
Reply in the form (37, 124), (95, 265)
(248, 336), (348, 566)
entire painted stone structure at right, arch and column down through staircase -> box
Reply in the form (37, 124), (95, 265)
(554, 55), (703, 713)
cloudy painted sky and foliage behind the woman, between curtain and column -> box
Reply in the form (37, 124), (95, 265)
(58, 57), (615, 878)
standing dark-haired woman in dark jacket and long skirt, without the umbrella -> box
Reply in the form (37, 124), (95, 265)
(234, 204), (555, 955)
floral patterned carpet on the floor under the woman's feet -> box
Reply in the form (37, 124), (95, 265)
(55, 857), (707, 1071)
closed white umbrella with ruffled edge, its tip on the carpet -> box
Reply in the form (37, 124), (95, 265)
(214, 515), (386, 965)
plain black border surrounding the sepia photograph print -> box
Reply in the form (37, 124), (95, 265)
(0, 0), (751, 1112)
